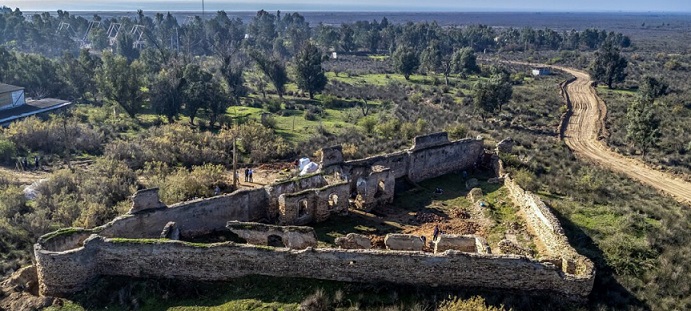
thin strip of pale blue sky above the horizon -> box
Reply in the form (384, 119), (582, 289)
(0, 0), (691, 13)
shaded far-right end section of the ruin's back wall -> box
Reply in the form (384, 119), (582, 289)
(408, 139), (484, 182)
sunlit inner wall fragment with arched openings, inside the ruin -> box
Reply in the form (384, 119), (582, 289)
(278, 182), (350, 225)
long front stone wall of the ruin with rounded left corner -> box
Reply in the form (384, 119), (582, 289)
(37, 237), (592, 297)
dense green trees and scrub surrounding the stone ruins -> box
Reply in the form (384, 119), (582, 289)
(0, 5), (691, 310)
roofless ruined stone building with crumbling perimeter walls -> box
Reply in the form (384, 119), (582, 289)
(34, 133), (594, 297)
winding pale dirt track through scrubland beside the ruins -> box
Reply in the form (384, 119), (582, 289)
(556, 65), (691, 204)
